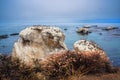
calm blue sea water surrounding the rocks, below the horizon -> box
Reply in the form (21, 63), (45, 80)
(0, 23), (120, 66)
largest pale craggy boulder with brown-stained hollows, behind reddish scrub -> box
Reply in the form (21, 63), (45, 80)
(12, 26), (67, 66)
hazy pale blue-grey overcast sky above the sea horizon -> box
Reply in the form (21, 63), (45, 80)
(0, 0), (120, 20)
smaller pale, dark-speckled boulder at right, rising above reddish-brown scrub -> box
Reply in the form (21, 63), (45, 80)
(74, 40), (110, 63)
